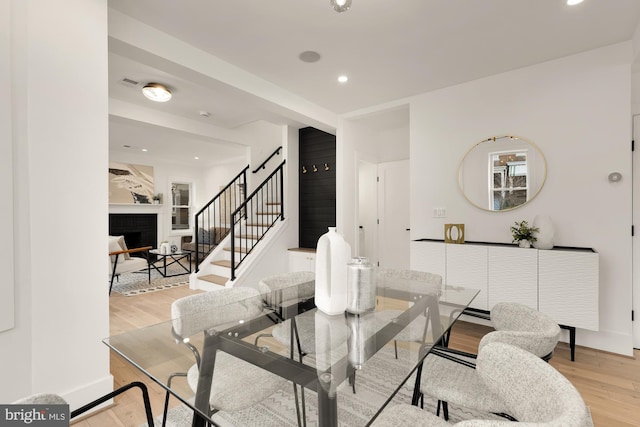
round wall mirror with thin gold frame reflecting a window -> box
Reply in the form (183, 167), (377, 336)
(458, 135), (547, 212)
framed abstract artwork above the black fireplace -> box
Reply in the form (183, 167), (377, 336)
(109, 162), (154, 204)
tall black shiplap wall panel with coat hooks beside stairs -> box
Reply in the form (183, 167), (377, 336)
(298, 127), (336, 249)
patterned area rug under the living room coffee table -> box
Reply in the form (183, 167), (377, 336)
(112, 265), (189, 297)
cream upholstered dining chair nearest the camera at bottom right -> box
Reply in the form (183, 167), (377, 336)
(371, 342), (593, 427)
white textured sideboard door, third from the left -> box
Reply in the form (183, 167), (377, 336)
(488, 246), (538, 310)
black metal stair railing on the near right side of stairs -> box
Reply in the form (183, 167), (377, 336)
(230, 160), (286, 280)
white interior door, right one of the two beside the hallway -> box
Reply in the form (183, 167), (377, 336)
(378, 160), (410, 269)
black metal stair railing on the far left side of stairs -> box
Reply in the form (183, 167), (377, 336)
(194, 165), (249, 273)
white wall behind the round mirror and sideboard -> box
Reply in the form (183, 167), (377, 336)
(411, 43), (632, 354)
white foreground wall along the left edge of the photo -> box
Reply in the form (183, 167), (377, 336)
(0, 0), (113, 408)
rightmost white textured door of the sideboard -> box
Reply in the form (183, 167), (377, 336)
(538, 250), (600, 331)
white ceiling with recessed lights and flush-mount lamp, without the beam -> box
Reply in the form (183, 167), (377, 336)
(109, 0), (640, 159)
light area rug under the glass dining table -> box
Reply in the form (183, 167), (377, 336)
(141, 348), (504, 427)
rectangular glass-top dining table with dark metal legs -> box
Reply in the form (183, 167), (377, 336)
(103, 278), (479, 426)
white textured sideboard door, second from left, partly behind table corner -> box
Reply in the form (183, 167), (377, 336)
(445, 244), (488, 310)
